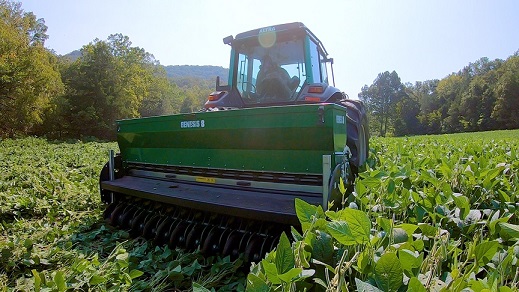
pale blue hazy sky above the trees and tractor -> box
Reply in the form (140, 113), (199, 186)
(22, 0), (519, 97)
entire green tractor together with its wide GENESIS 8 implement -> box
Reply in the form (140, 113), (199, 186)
(100, 23), (369, 261)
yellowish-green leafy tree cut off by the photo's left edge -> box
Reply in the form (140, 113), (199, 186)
(0, 0), (63, 136)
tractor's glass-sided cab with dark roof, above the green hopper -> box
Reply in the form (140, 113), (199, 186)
(204, 22), (342, 108)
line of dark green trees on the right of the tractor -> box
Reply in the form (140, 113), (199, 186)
(358, 51), (519, 136)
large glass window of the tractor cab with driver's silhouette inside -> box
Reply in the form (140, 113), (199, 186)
(237, 40), (306, 104)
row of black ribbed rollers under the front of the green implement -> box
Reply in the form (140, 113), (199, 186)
(104, 197), (282, 262)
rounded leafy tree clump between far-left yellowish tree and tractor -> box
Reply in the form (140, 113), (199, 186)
(59, 34), (178, 138)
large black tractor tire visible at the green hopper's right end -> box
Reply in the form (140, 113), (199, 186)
(341, 99), (369, 175)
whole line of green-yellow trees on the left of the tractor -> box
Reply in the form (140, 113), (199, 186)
(0, 0), (214, 139)
